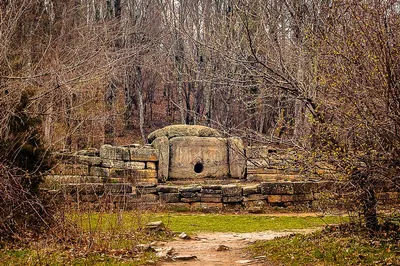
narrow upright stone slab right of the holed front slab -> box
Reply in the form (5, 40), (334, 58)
(227, 137), (246, 179)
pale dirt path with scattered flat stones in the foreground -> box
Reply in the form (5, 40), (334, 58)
(157, 229), (314, 266)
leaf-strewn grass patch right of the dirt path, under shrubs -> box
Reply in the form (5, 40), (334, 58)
(249, 222), (400, 265)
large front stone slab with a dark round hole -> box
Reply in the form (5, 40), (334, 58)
(169, 137), (229, 179)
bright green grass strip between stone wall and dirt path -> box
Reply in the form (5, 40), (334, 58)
(72, 212), (347, 234)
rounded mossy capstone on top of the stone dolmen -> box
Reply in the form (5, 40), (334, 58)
(147, 125), (221, 143)
